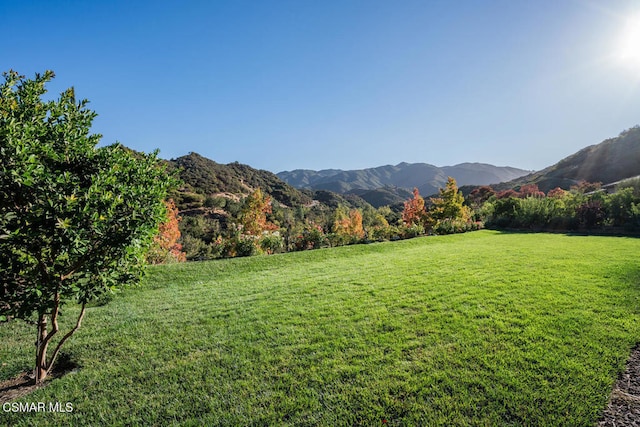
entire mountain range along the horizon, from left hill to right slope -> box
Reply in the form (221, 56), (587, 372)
(168, 126), (640, 211)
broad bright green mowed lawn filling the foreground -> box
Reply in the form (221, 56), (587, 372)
(0, 231), (640, 426)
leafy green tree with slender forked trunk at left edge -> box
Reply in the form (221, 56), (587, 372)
(0, 71), (176, 383)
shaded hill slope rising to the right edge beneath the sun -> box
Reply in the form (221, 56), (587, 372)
(493, 126), (640, 192)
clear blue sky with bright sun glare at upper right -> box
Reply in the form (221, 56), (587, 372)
(0, 0), (640, 172)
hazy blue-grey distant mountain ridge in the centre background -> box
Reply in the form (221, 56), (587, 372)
(277, 163), (530, 199)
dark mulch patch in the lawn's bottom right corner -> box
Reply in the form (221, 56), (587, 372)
(598, 345), (640, 427)
